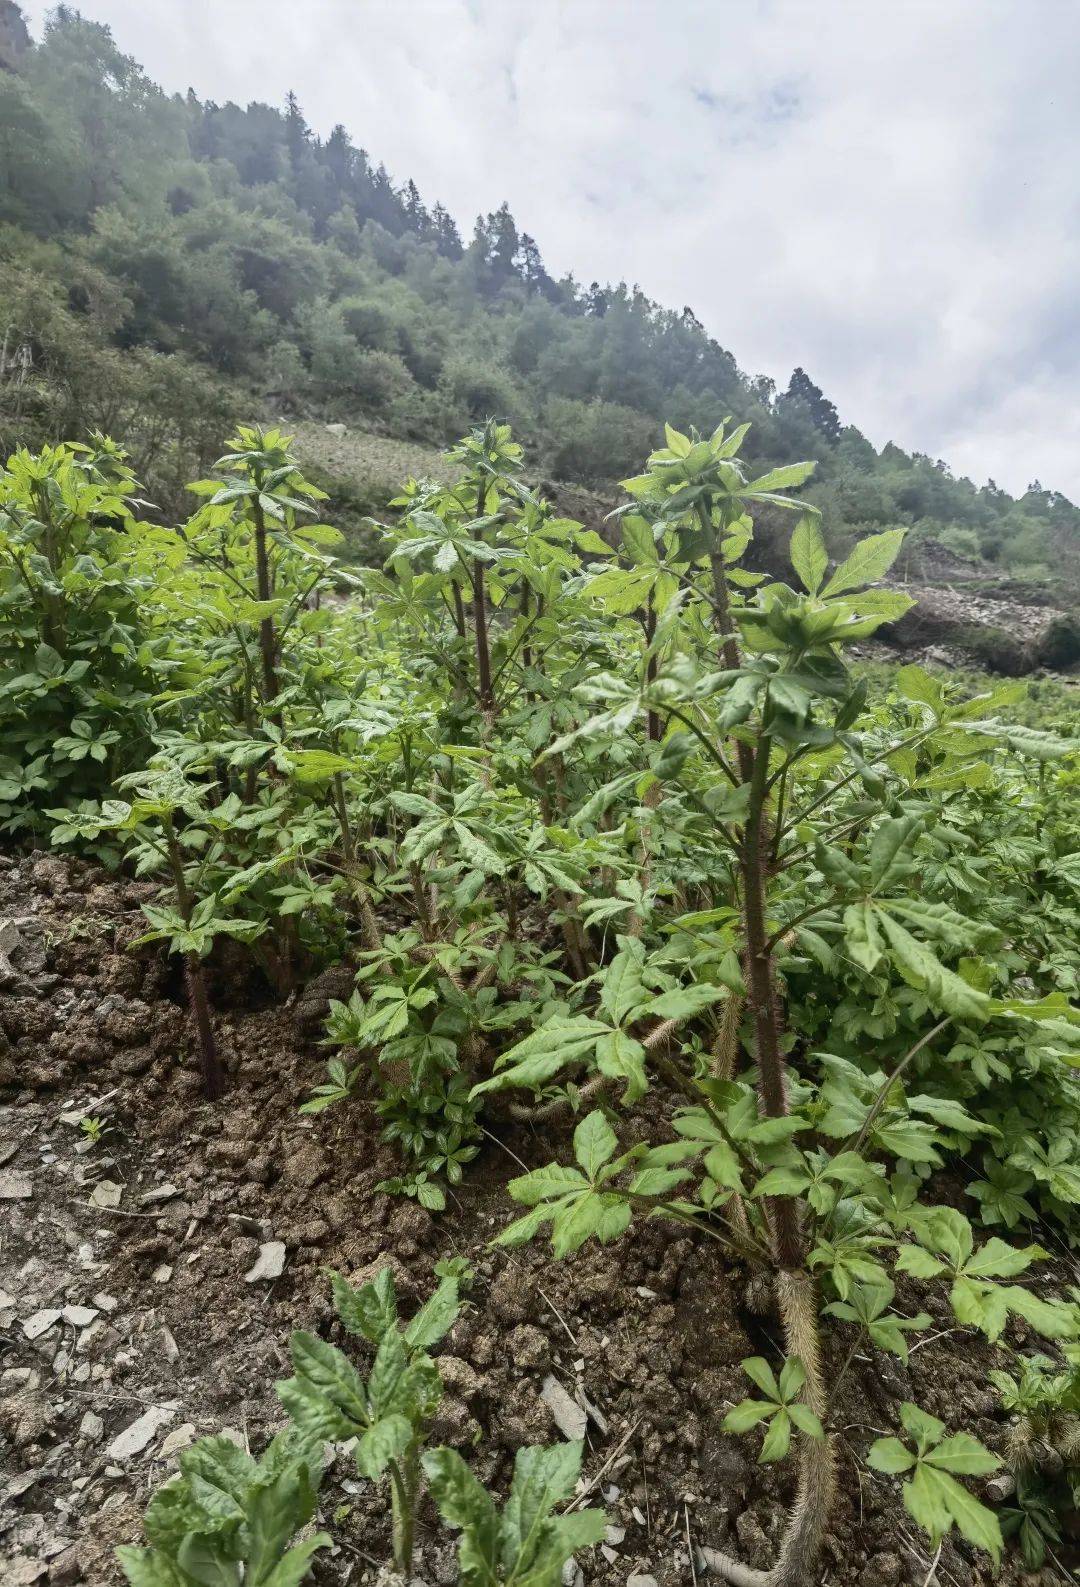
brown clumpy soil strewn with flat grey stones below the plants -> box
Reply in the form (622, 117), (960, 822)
(0, 854), (1077, 1587)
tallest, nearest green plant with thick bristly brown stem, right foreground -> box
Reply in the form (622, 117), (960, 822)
(476, 428), (1077, 1587)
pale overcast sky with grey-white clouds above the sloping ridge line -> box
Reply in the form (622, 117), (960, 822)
(24, 0), (1080, 501)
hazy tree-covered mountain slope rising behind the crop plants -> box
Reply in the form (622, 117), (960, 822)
(0, 0), (1080, 641)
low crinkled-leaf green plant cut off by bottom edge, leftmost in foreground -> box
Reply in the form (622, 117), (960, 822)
(116, 1431), (331, 1587)
